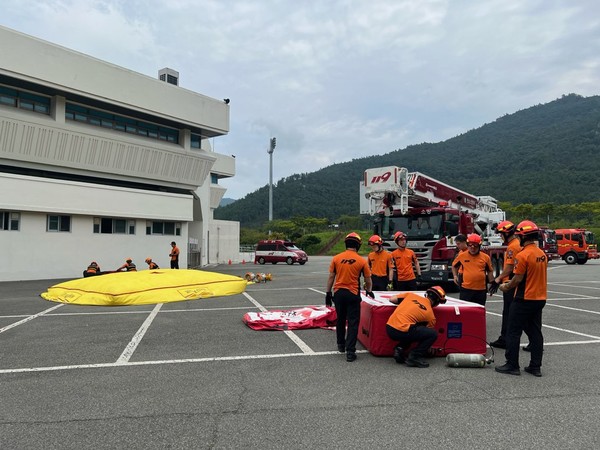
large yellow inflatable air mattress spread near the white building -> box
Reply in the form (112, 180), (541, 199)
(40, 269), (247, 306)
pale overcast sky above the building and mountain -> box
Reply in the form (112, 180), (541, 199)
(0, 0), (600, 199)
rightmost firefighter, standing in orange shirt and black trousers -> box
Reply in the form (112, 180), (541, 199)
(496, 220), (548, 377)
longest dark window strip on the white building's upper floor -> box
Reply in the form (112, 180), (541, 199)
(65, 103), (179, 144)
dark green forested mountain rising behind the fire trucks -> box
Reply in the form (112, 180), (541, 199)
(215, 94), (600, 226)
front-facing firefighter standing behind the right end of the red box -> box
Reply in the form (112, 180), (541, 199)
(452, 233), (494, 306)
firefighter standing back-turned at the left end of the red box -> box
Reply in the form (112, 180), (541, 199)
(325, 233), (375, 362)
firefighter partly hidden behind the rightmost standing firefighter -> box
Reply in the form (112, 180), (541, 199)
(488, 220), (521, 348)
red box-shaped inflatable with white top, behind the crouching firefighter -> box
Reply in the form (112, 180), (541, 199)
(358, 292), (487, 356)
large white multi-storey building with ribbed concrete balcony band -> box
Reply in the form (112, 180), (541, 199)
(0, 26), (239, 281)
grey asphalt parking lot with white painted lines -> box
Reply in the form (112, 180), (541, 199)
(0, 257), (600, 449)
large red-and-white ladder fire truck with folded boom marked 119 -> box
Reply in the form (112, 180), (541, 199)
(360, 166), (506, 284)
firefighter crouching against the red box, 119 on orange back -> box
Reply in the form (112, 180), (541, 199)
(386, 286), (446, 367)
